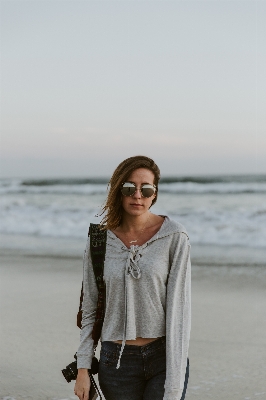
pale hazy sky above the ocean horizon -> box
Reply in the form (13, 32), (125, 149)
(0, 0), (266, 178)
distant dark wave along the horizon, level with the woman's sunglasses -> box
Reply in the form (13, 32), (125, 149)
(0, 175), (266, 195)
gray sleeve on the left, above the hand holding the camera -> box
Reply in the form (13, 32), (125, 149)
(77, 239), (98, 369)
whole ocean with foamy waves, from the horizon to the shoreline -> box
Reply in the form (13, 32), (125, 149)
(0, 175), (266, 252)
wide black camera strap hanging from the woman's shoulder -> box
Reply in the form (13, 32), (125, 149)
(77, 224), (107, 347)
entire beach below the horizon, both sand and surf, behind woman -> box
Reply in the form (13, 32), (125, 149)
(0, 175), (266, 400)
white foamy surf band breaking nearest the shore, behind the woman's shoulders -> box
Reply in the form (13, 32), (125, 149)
(0, 201), (266, 247)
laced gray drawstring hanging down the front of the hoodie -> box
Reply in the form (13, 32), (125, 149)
(116, 245), (141, 369)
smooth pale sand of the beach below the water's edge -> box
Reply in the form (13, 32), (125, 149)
(0, 249), (266, 400)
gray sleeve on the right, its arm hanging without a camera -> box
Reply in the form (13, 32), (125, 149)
(163, 233), (191, 400)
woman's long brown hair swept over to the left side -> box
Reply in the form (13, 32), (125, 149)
(101, 156), (160, 229)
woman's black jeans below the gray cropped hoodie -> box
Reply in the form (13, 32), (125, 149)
(99, 337), (189, 400)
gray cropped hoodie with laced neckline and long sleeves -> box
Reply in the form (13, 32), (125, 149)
(77, 217), (191, 400)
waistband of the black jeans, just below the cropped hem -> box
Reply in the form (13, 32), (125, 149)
(102, 336), (166, 354)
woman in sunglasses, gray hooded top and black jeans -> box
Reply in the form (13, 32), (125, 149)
(74, 156), (191, 400)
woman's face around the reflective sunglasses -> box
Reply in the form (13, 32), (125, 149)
(122, 168), (156, 216)
